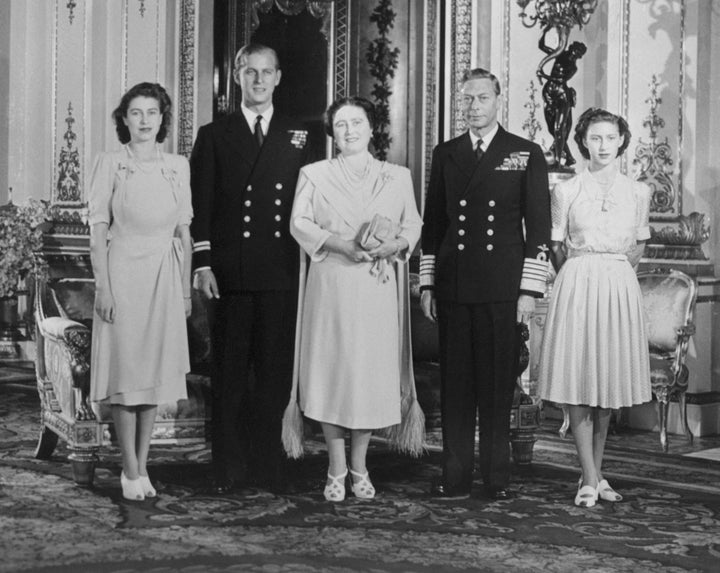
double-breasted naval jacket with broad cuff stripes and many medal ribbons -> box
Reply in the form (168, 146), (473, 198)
(420, 126), (550, 304)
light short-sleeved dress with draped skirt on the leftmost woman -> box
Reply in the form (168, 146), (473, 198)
(88, 147), (192, 406)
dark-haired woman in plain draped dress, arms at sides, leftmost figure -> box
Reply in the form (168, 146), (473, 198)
(88, 83), (192, 500)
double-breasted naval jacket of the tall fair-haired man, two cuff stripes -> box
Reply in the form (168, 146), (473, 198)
(190, 110), (309, 294)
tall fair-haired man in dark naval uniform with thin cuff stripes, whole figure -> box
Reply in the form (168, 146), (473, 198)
(190, 44), (309, 493)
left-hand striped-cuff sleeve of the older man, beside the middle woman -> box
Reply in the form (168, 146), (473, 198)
(420, 147), (449, 291)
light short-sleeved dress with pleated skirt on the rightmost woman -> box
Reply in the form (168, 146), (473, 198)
(538, 170), (651, 408)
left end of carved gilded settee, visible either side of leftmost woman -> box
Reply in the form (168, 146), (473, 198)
(35, 257), (210, 485)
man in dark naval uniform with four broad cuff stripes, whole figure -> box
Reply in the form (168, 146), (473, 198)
(420, 69), (550, 499)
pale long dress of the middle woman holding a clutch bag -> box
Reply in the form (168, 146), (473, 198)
(290, 157), (422, 429)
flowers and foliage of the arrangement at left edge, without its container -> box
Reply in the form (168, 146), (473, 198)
(0, 199), (51, 298)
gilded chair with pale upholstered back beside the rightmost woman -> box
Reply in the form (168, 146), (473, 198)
(638, 270), (697, 452)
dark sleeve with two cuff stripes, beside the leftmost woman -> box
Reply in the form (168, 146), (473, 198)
(190, 125), (215, 270)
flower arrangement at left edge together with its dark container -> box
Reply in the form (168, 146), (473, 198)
(0, 199), (50, 341)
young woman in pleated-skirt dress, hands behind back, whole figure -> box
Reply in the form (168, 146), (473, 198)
(539, 108), (651, 507)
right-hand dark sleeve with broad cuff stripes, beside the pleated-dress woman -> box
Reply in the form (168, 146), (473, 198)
(520, 145), (550, 297)
